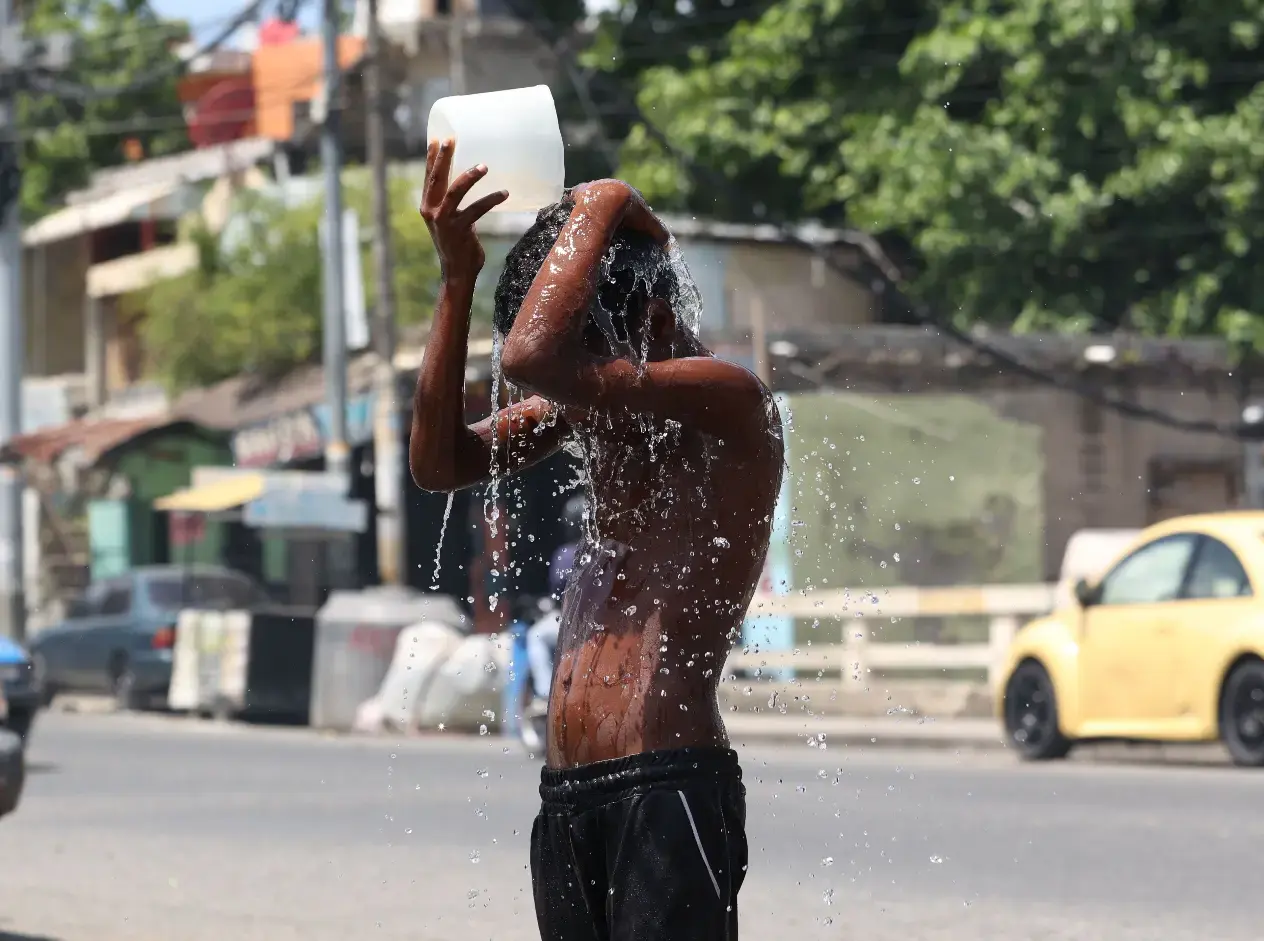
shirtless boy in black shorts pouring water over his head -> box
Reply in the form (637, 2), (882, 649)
(410, 142), (782, 941)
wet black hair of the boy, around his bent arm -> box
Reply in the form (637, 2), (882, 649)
(492, 190), (679, 340)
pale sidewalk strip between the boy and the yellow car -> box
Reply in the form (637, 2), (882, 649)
(724, 713), (1005, 751)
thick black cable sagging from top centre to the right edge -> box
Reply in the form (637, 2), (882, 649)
(490, 0), (1264, 440)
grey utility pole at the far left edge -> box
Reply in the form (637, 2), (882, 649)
(0, 9), (71, 640)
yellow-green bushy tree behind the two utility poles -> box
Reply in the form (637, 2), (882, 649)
(138, 175), (449, 391)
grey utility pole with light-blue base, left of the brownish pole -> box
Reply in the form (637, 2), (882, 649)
(318, 0), (351, 481)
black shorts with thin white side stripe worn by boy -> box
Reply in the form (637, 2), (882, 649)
(531, 749), (747, 941)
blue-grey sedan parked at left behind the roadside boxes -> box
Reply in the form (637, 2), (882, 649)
(30, 565), (267, 708)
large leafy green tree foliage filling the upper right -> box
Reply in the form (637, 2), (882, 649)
(622, 0), (1264, 347)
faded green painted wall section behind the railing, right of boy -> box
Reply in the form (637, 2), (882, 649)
(787, 392), (1044, 641)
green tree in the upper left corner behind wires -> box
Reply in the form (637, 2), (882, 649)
(18, 0), (188, 219)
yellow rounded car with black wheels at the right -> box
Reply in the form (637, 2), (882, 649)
(996, 512), (1264, 766)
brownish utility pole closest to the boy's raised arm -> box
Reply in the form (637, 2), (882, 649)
(364, 0), (408, 586)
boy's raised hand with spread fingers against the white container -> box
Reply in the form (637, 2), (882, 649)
(421, 140), (509, 283)
